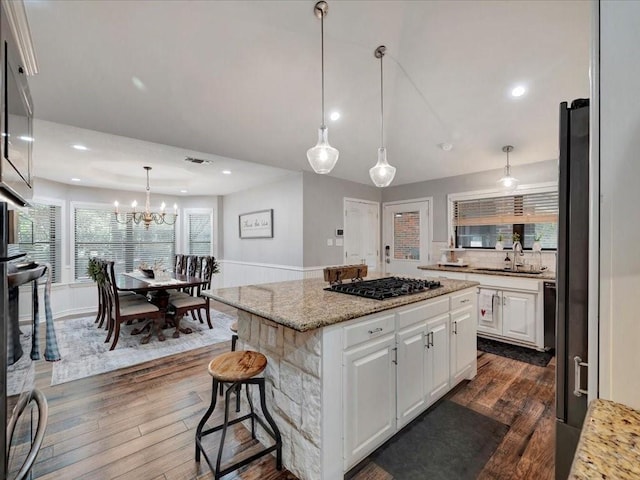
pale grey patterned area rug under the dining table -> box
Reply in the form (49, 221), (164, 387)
(51, 310), (235, 385)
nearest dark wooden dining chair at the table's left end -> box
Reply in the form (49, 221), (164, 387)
(105, 262), (164, 350)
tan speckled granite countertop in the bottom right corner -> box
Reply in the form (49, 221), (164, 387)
(569, 399), (640, 480)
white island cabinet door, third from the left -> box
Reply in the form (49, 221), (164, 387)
(425, 313), (449, 405)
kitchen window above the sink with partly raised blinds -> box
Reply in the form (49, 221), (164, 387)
(453, 191), (558, 249)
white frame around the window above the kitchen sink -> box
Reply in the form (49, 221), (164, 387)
(447, 182), (558, 252)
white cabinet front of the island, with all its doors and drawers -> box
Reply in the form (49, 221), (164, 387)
(340, 288), (477, 471)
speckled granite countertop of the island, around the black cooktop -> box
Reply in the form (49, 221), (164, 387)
(202, 275), (479, 332)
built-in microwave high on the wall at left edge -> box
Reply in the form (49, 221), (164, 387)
(0, 13), (33, 206)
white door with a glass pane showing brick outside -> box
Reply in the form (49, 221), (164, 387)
(382, 200), (429, 275)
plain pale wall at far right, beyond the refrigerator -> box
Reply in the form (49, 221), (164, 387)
(599, 1), (640, 409)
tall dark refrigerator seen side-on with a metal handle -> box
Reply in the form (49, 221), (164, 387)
(556, 99), (589, 480)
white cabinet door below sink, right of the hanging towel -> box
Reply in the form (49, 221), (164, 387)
(502, 290), (536, 343)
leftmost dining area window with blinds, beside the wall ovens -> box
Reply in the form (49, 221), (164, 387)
(17, 203), (62, 282)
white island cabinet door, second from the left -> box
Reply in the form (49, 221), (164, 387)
(396, 321), (426, 428)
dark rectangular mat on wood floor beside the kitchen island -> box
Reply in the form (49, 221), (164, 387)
(369, 400), (509, 480)
